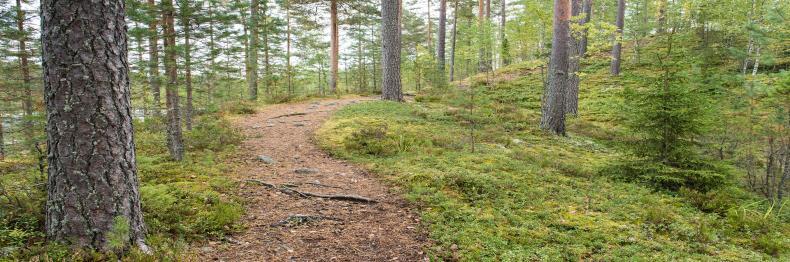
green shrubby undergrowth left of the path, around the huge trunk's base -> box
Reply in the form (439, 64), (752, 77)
(0, 109), (246, 261)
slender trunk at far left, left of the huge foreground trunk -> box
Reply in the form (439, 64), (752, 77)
(16, 0), (34, 143)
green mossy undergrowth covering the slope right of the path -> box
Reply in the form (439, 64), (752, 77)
(316, 64), (790, 261)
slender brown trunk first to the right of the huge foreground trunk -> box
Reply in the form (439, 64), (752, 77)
(148, 0), (162, 116)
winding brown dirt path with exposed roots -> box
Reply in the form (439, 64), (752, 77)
(198, 98), (428, 261)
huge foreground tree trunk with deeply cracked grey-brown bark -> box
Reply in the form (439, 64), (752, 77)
(41, 0), (148, 251)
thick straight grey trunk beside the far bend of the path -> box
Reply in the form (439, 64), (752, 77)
(381, 0), (403, 102)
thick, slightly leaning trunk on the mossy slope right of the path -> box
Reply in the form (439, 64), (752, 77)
(540, 0), (571, 136)
